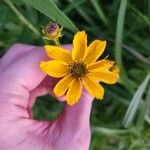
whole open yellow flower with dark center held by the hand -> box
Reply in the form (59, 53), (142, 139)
(40, 31), (119, 105)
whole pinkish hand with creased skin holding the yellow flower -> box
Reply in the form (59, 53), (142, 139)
(0, 44), (93, 150)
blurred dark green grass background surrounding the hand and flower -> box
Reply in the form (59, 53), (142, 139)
(0, 0), (150, 150)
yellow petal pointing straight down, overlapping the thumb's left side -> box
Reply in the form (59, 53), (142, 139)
(66, 79), (82, 105)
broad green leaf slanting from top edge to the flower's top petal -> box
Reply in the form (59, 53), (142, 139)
(23, 0), (78, 32)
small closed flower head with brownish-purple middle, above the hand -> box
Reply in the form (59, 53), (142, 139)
(42, 22), (63, 40)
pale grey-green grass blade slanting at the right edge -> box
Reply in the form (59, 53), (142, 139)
(123, 73), (150, 128)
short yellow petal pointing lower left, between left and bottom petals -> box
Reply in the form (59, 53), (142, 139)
(54, 76), (72, 97)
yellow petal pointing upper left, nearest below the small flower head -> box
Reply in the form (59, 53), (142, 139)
(44, 45), (72, 62)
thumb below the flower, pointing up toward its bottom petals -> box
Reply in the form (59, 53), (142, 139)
(54, 91), (93, 150)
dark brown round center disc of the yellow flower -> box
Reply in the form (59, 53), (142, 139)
(69, 62), (88, 79)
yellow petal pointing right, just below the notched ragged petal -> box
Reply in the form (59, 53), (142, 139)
(88, 71), (119, 84)
